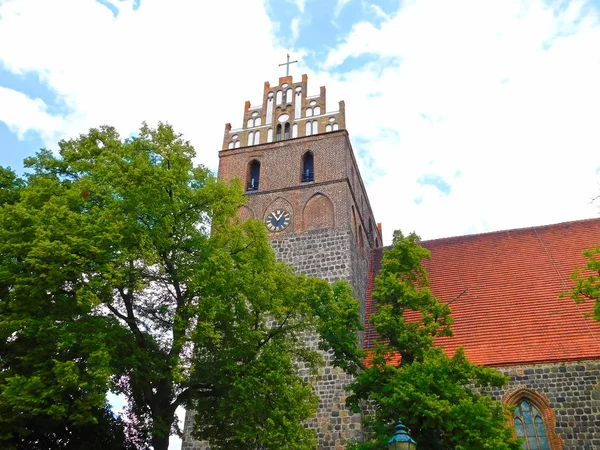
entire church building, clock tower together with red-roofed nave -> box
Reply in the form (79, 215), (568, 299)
(182, 67), (600, 450)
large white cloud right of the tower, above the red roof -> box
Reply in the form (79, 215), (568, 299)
(318, 0), (600, 243)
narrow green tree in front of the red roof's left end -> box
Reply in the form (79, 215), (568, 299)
(348, 231), (521, 450)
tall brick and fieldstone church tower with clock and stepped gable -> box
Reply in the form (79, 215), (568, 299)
(183, 75), (382, 450)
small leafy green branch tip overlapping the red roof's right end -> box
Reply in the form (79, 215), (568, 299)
(561, 247), (600, 321)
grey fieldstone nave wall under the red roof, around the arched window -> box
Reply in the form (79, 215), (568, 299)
(491, 361), (600, 450)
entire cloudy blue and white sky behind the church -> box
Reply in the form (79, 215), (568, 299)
(0, 0), (600, 448)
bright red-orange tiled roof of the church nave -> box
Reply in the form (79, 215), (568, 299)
(365, 219), (600, 366)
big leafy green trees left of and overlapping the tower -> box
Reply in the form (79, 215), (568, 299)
(0, 124), (360, 450)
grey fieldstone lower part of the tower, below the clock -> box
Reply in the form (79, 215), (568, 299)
(182, 229), (368, 450)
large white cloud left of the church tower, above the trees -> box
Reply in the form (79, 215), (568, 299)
(0, 0), (286, 169)
